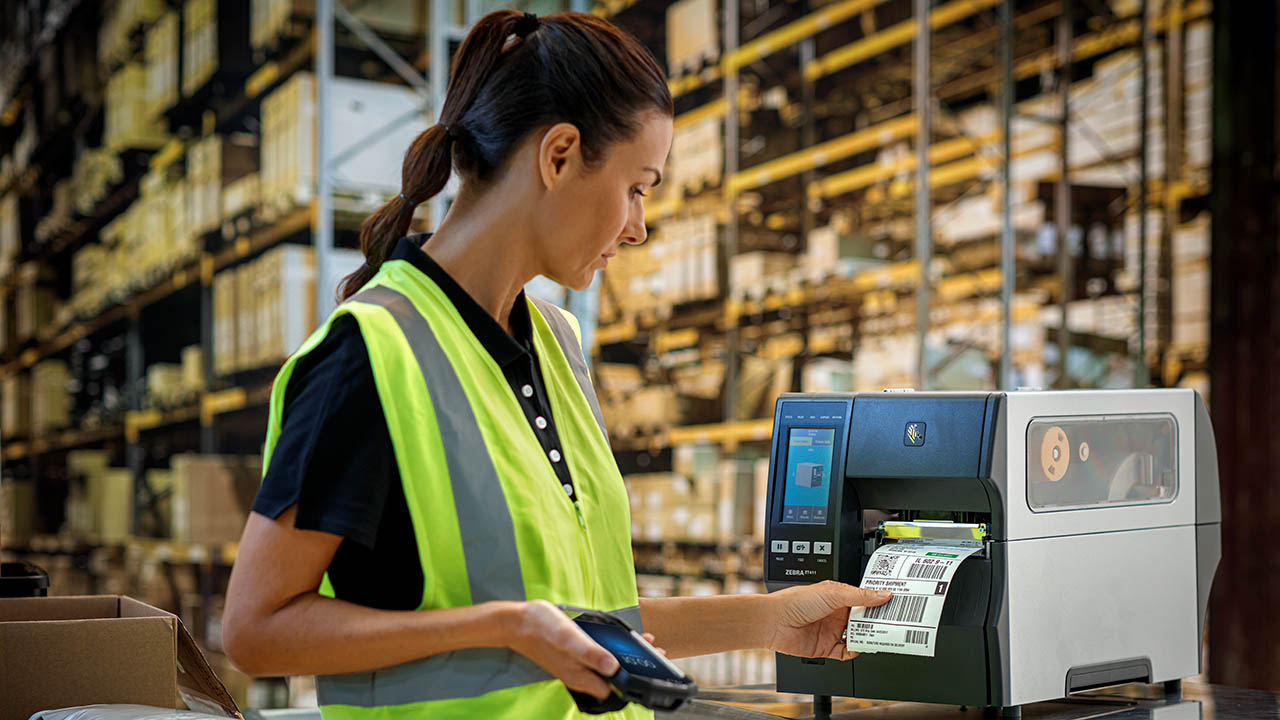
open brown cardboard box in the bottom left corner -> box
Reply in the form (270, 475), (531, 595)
(0, 596), (241, 720)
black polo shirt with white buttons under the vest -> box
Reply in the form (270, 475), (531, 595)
(253, 233), (573, 610)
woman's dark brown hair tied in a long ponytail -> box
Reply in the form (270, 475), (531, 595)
(338, 10), (675, 300)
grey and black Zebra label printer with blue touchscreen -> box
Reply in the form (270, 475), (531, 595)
(764, 389), (1221, 714)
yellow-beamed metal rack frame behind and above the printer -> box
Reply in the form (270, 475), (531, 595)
(596, 0), (1210, 448)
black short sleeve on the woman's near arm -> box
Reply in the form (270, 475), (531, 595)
(253, 315), (399, 550)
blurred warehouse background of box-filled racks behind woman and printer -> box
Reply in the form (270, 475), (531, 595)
(0, 0), (1280, 707)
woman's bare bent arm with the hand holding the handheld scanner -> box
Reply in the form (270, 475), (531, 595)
(223, 507), (617, 698)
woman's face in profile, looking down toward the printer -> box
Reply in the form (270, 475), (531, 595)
(538, 111), (672, 290)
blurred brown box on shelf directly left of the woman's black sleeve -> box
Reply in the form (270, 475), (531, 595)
(169, 454), (262, 544)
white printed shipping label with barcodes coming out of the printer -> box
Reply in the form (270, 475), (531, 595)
(845, 543), (982, 657)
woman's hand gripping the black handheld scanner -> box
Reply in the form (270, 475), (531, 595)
(499, 600), (618, 700)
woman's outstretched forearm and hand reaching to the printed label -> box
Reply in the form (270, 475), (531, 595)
(640, 580), (890, 660)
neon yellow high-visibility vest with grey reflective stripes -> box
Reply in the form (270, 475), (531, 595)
(264, 260), (653, 720)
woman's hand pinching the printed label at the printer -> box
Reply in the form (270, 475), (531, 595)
(767, 580), (892, 660)
